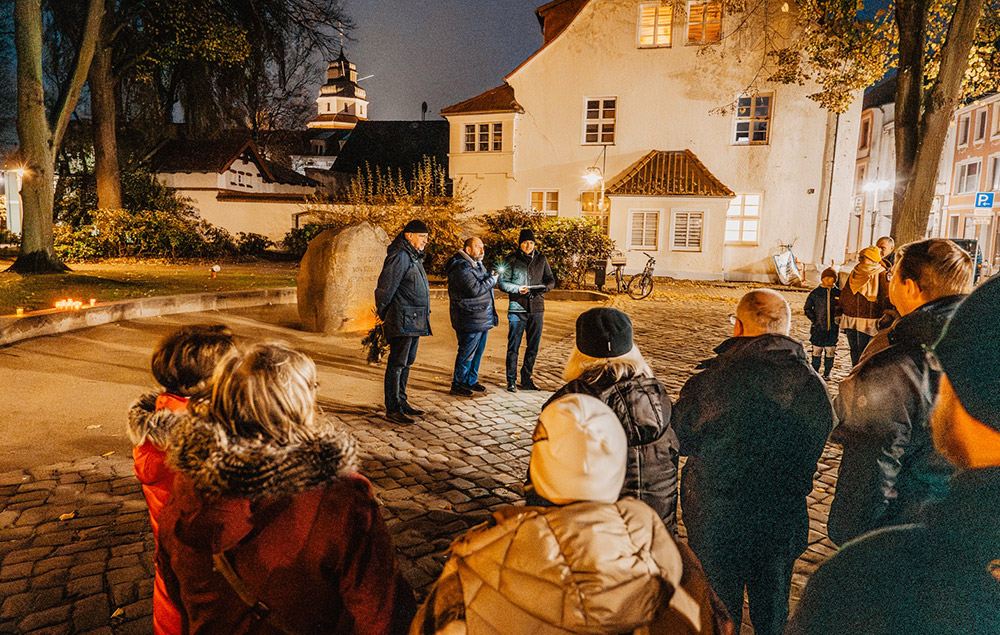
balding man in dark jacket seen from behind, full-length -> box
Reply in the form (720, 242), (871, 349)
(673, 289), (833, 635)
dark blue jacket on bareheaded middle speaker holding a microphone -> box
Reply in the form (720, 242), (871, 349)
(445, 251), (499, 333)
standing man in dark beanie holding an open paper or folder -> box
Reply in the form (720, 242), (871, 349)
(499, 229), (556, 392)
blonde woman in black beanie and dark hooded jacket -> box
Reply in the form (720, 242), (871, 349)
(525, 307), (680, 534)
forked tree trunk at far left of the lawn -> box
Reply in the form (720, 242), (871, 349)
(9, 0), (104, 273)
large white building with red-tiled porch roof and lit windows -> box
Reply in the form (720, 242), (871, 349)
(442, 0), (861, 280)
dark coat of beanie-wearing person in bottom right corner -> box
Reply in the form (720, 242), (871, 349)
(785, 467), (1000, 635)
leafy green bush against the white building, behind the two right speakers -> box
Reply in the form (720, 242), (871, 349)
(477, 206), (614, 286)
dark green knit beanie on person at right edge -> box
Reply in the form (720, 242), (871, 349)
(934, 278), (1000, 432)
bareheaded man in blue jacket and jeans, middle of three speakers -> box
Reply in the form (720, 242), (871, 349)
(445, 238), (499, 397)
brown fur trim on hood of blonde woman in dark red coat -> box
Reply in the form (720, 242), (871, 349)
(167, 415), (359, 500)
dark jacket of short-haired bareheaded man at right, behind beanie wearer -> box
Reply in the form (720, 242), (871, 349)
(827, 295), (965, 544)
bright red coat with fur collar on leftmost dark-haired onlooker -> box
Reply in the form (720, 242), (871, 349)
(128, 393), (188, 635)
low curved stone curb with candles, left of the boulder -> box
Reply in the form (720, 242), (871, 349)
(0, 287), (296, 346)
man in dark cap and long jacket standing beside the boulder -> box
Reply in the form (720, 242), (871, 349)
(375, 220), (431, 423)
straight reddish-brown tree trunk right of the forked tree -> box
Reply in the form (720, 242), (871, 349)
(87, 24), (122, 209)
